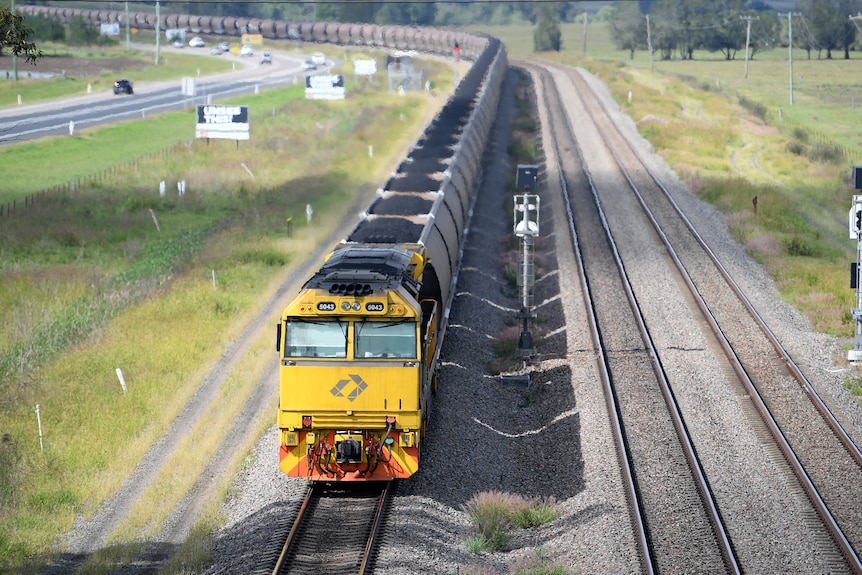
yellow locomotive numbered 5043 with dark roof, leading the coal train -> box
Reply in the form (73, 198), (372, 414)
(278, 245), (439, 481)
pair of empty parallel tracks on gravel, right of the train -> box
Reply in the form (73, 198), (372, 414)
(519, 59), (862, 572)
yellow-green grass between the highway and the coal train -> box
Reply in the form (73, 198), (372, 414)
(0, 53), (460, 572)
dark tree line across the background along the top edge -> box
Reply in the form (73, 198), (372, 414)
(10, 0), (862, 60)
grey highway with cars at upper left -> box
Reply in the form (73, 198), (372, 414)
(0, 48), (316, 145)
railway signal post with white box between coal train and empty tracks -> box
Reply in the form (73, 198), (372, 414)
(514, 164), (540, 357)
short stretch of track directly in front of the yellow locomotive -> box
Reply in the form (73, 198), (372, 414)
(271, 482), (396, 575)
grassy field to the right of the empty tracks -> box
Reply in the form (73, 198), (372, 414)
(472, 23), (862, 346)
